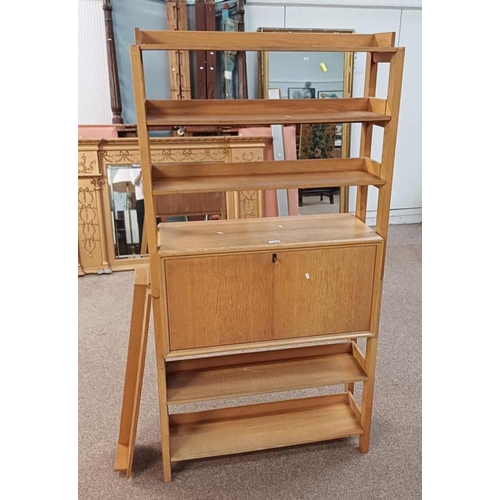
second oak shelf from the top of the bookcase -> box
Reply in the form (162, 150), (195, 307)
(146, 97), (391, 127)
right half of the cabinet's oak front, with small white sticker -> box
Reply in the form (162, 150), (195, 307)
(273, 246), (376, 339)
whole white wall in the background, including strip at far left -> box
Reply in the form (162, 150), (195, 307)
(78, 0), (422, 224)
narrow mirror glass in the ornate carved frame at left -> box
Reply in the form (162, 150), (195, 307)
(107, 165), (146, 259)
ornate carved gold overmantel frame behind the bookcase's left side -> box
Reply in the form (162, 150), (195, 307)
(78, 136), (269, 275)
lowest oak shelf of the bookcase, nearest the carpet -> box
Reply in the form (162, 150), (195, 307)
(170, 393), (363, 462)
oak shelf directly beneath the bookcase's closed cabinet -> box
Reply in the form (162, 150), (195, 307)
(167, 342), (367, 405)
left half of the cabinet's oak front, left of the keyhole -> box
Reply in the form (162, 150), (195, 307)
(165, 254), (273, 351)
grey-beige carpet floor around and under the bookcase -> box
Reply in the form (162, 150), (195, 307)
(78, 224), (422, 500)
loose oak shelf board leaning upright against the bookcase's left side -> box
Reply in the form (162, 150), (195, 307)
(115, 267), (151, 477)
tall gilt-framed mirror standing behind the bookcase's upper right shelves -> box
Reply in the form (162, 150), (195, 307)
(257, 28), (354, 213)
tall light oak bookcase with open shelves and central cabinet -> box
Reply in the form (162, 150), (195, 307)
(121, 29), (404, 481)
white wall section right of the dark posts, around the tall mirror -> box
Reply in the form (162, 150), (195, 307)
(245, 0), (422, 224)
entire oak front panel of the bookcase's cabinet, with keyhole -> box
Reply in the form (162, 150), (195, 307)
(165, 245), (376, 351)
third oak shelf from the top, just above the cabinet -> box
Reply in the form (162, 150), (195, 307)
(153, 158), (385, 195)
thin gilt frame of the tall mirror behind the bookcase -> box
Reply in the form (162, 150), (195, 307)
(257, 28), (354, 213)
